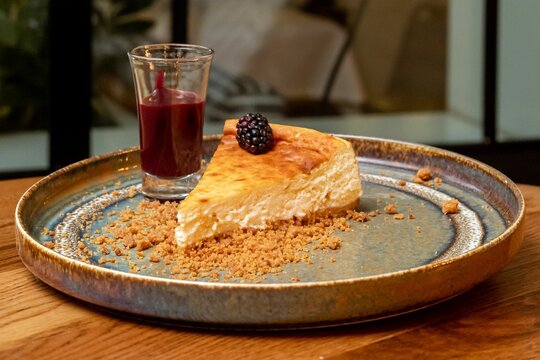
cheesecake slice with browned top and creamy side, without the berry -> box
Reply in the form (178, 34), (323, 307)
(176, 120), (362, 246)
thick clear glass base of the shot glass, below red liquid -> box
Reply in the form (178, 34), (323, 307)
(142, 171), (202, 200)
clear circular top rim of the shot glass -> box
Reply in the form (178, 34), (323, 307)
(128, 43), (214, 62)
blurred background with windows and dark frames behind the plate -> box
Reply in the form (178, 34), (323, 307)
(0, 0), (540, 184)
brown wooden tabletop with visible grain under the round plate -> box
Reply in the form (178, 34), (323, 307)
(0, 178), (540, 359)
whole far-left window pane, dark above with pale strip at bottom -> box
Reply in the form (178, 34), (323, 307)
(0, 0), (50, 173)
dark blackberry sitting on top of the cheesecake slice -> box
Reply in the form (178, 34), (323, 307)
(236, 113), (274, 154)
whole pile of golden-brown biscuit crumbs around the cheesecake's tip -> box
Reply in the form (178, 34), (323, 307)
(84, 201), (376, 281)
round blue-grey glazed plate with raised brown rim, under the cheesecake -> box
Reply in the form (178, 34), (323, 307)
(15, 136), (524, 329)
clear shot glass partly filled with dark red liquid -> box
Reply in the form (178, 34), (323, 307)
(128, 44), (214, 200)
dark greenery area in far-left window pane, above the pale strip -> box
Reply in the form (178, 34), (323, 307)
(0, 0), (49, 132)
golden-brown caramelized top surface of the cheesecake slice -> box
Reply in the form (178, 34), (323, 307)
(189, 120), (346, 203)
